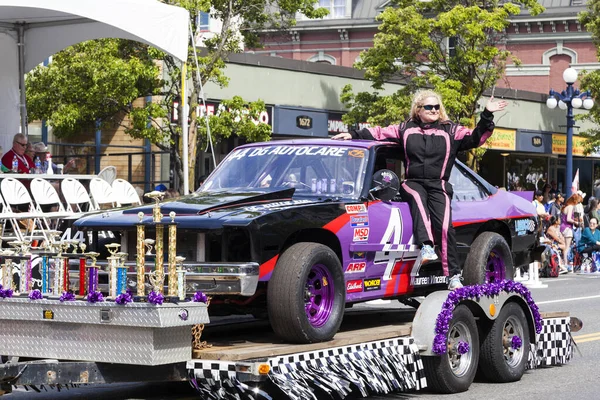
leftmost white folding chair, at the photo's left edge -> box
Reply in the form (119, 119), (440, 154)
(0, 178), (50, 241)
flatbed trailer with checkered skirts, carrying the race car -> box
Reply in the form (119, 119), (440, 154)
(0, 291), (581, 399)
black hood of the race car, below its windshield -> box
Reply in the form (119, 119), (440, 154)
(74, 188), (320, 230)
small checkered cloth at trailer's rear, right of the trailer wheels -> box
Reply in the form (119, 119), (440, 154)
(528, 317), (573, 369)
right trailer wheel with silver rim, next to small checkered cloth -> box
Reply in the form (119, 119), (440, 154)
(479, 302), (530, 383)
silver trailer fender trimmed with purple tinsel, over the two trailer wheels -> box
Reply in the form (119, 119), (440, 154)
(412, 290), (536, 356)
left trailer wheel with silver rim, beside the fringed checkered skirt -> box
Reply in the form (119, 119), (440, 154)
(423, 305), (479, 393)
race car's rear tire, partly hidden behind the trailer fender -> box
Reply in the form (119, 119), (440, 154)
(463, 232), (514, 285)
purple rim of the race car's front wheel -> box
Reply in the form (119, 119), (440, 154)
(304, 264), (335, 328)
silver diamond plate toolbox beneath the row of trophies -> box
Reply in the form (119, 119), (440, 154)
(0, 298), (208, 365)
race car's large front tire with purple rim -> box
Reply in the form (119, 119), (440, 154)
(267, 243), (346, 343)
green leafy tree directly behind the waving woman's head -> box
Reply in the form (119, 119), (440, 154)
(341, 0), (543, 169)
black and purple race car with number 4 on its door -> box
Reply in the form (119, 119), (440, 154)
(75, 140), (537, 343)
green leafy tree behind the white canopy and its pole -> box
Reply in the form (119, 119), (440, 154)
(27, 0), (327, 191)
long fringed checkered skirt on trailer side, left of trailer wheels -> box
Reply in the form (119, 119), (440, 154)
(269, 338), (427, 400)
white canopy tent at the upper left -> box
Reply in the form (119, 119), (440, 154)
(0, 0), (189, 186)
